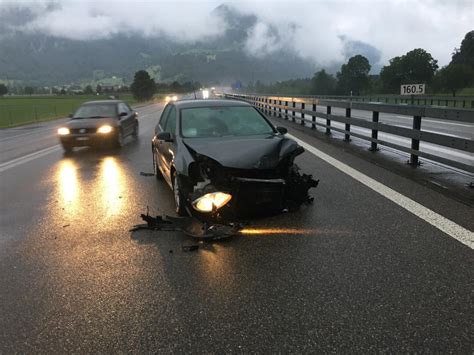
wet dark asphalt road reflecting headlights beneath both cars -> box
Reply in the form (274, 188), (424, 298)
(0, 101), (474, 353)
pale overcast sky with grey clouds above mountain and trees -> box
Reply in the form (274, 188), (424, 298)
(0, 0), (474, 65)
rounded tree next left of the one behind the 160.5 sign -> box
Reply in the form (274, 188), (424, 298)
(337, 54), (371, 95)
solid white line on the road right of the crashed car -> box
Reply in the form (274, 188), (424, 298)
(288, 134), (474, 249)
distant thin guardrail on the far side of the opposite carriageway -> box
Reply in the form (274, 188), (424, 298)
(241, 93), (474, 108)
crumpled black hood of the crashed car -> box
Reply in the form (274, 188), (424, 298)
(183, 136), (303, 169)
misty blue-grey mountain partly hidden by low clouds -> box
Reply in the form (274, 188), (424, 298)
(0, 5), (316, 85)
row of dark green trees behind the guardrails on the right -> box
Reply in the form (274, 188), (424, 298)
(244, 31), (474, 96)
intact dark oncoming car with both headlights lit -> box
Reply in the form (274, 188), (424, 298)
(57, 100), (138, 153)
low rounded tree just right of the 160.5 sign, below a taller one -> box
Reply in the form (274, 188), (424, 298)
(434, 62), (474, 96)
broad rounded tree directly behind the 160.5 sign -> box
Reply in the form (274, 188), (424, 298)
(380, 48), (438, 92)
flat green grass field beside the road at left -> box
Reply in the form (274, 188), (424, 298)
(0, 94), (150, 127)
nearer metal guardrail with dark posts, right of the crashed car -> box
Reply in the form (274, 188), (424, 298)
(224, 93), (474, 173)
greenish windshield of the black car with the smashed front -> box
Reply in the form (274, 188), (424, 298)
(181, 106), (275, 138)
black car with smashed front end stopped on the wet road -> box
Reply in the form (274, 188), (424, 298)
(152, 100), (318, 220)
